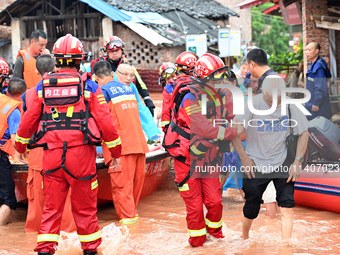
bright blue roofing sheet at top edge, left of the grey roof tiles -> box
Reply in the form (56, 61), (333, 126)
(79, 0), (131, 21)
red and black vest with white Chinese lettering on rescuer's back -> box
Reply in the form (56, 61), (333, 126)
(31, 70), (101, 149)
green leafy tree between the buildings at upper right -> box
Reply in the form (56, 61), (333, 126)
(251, 3), (289, 55)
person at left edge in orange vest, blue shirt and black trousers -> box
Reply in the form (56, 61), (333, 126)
(0, 78), (26, 226)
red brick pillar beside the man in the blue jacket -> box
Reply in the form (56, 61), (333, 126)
(302, 0), (329, 71)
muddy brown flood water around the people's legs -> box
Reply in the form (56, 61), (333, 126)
(0, 170), (340, 255)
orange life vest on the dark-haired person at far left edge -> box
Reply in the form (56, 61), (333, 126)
(0, 95), (20, 156)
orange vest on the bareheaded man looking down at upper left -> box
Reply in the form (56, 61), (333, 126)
(18, 49), (42, 89)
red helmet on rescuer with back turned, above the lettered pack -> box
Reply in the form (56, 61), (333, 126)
(52, 34), (85, 59)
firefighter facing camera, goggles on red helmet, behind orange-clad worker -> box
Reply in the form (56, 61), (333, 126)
(91, 35), (155, 116)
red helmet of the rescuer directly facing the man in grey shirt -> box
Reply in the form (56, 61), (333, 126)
(194, 53), (231, 82)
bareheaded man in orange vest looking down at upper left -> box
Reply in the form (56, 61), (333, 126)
(13, 29), (50, 89)
